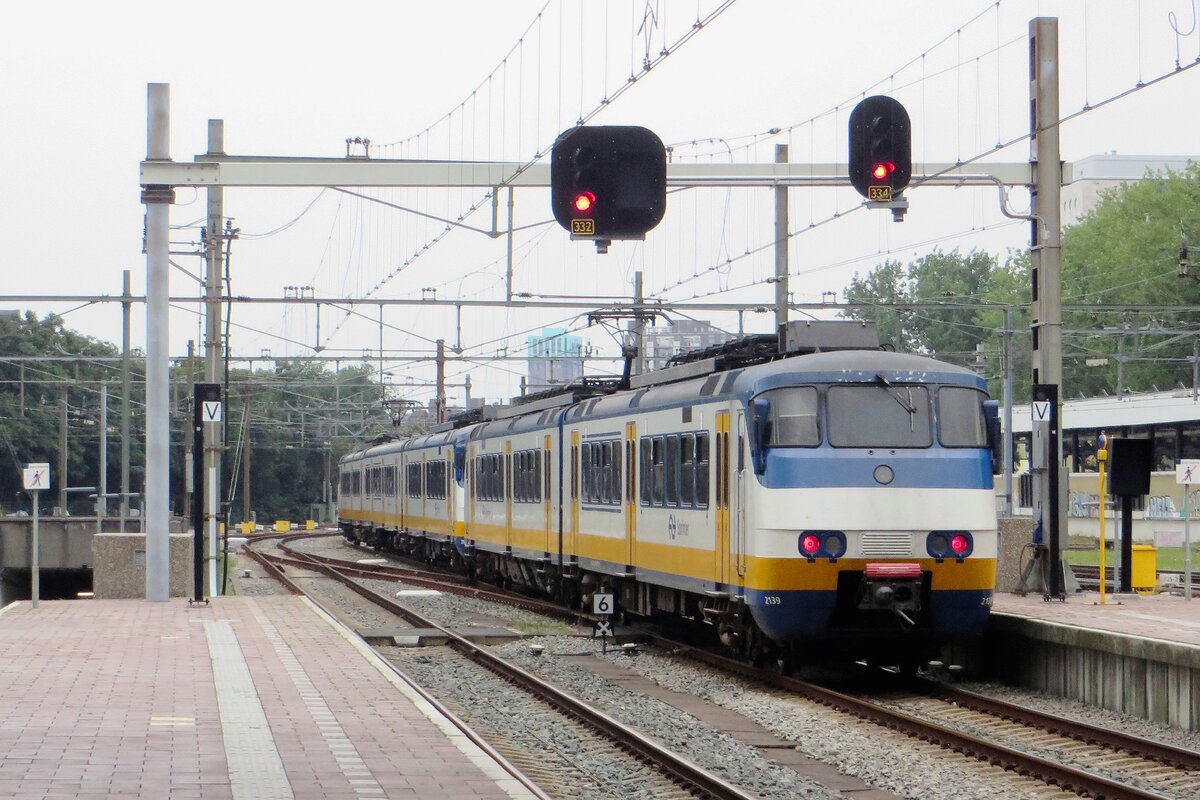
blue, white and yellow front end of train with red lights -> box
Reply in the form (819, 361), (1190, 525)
(739, 362), (998, 657)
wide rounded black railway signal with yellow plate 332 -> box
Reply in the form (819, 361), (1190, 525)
(550, 125), (667, 253)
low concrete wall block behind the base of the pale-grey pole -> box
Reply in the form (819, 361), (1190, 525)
(91, 534), (192, 600)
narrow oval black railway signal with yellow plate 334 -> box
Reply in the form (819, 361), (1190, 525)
(850, 95), (912, 208)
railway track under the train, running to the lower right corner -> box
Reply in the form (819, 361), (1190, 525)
(246, 534), (1200, 800)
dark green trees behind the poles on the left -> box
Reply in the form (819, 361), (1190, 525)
(0, 313), (391, 522)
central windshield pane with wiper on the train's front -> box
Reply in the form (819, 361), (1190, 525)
(828, 383), (934, 447)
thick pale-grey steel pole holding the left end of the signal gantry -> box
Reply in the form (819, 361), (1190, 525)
(142, 83), (174, 602)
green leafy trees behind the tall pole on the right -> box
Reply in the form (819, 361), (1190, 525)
(846, 164), (1200, 403)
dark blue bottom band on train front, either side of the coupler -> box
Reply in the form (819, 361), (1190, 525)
(746, 589), (991, 642)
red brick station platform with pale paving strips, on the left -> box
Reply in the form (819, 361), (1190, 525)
(0, 595), (538, 800)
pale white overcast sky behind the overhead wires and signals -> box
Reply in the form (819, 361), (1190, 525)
(0, 0), (1200, 403)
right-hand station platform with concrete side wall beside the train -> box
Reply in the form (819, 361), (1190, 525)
(984, 591), (1200, 730)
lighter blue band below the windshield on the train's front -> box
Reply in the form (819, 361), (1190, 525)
(758, 447), (992, 489)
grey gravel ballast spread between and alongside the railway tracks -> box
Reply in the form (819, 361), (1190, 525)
(248, 539), (1200, 800)
